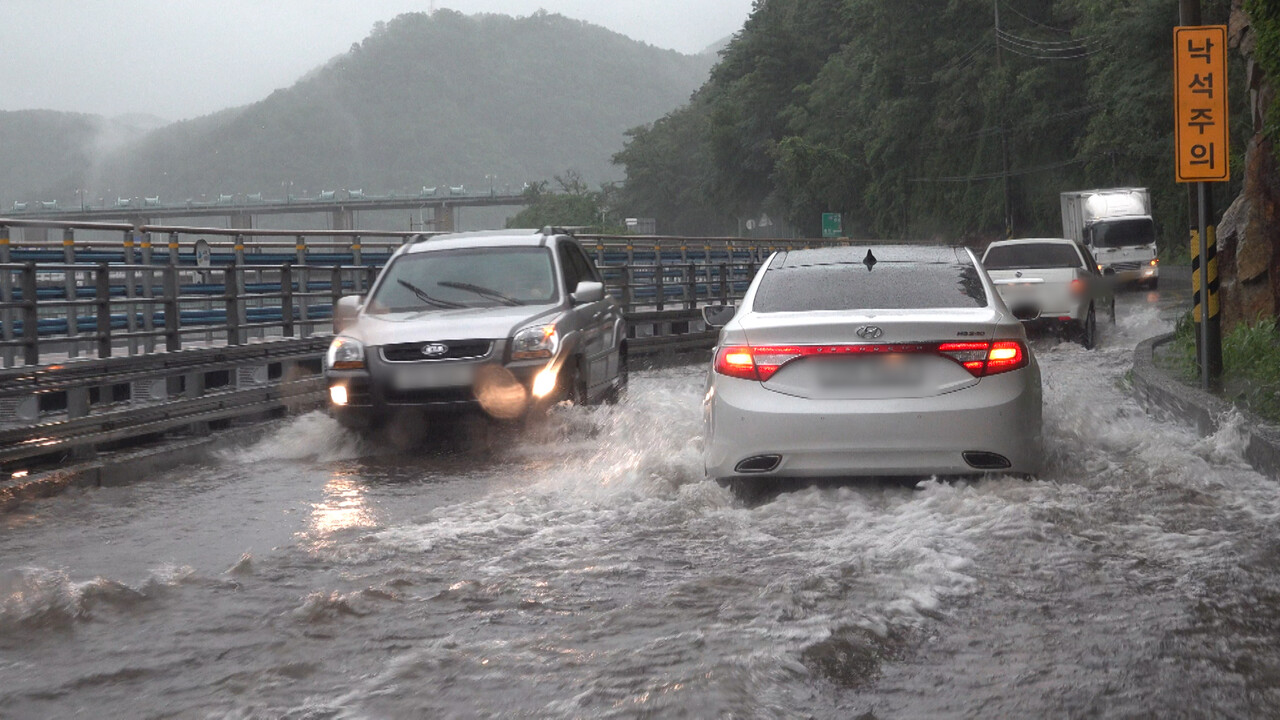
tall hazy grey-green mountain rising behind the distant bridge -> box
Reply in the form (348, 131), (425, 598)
(32, 10), (714, 201)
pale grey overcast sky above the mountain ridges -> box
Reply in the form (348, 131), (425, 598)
(0, 0), (753, 120)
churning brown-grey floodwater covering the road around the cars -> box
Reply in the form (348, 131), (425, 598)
(0, 271), (1280, 719)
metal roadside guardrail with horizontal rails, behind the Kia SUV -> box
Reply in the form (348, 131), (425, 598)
(0, 218), (849, 468)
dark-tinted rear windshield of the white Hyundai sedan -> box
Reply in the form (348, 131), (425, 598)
(753, 263), (987, 313)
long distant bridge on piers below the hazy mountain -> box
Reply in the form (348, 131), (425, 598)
(13, 188), (529, 233)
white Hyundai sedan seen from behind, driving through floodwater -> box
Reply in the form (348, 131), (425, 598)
(704, 245), (1042, 482)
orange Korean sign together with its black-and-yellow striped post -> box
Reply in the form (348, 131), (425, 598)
(1174, 26), (1231, 389)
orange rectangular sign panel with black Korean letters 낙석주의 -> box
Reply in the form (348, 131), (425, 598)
(1174, 26), (1231, 182)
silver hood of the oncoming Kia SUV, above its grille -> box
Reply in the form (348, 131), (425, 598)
(342, 305), (559, 347)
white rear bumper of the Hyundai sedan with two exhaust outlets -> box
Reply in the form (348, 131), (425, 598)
(705, 364), (1042, 478)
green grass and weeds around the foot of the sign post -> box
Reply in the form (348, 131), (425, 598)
(1161, 313), (1280, 423)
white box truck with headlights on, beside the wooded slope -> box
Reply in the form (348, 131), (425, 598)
(1062, 187), (1160, 288)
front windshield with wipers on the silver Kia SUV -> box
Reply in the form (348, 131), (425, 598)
(369, 247), (557, 313)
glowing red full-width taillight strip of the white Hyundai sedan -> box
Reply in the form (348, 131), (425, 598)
(714, 340), (1028, 383)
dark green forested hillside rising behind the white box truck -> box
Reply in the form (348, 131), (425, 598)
(616, 0), (1245, 245)
